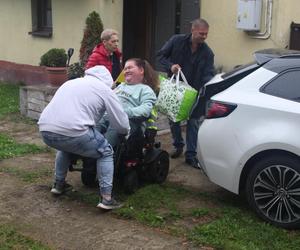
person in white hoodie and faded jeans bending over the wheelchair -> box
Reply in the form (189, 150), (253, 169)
(38, 66), (130, 209)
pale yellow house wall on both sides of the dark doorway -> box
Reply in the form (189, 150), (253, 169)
(0, 0), (300, 70)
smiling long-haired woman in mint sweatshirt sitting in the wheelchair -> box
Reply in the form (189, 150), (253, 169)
(97, 58), (159, 148)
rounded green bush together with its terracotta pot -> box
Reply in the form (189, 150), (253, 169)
(40, 48), (68, 86)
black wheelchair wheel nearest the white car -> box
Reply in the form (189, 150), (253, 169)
(149, 151), (170, 183)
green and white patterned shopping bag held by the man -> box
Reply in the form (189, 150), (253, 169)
(156, 70), (198, 122)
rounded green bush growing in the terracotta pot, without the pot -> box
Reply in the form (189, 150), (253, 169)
(40, 48), (68, 67)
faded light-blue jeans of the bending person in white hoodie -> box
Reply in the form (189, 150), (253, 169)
(41, 127), (114, 195)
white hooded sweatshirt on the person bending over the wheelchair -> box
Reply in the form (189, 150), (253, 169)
(38, 66), (130, 137)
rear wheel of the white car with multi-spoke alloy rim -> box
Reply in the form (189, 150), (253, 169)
(246, 156), (300, 229)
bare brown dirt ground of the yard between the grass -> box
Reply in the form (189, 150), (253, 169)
(0, 118), (219, 250)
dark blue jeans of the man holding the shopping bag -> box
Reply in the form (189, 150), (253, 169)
(169, 118), (203, 159)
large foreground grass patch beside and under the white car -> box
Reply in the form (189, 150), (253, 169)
(67, 183), (300, 250)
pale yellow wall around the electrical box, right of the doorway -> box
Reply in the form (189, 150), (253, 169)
(201, 0), (300, 70)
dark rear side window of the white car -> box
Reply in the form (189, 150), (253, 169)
(261, 69), (300, 102)
